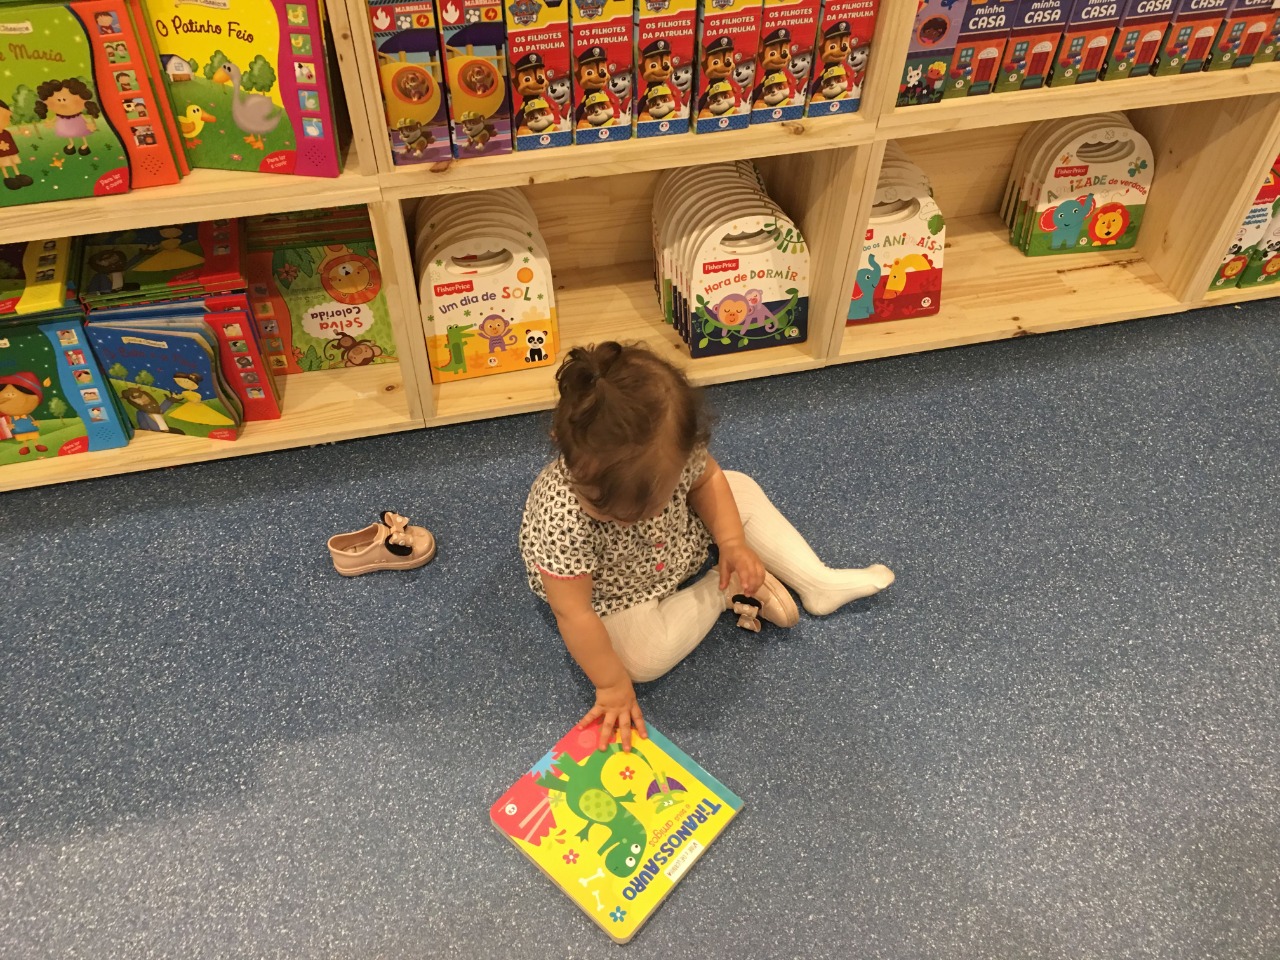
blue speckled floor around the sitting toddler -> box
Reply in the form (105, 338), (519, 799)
(0, 306), (1280, 960)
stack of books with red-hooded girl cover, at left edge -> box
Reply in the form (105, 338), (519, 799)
(0, 239), (129, 466)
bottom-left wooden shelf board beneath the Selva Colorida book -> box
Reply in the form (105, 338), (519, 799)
(0, 364), (424, 492)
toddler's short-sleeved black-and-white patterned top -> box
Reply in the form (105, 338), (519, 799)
(520, 447), (712, 617)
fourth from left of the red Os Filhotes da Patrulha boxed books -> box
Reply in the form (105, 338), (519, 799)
(694, 0), (762, 133)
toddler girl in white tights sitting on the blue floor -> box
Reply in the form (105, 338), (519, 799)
(520, 342), (893, 749)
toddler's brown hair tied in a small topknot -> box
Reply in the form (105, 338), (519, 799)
(552, 340), (710, 522)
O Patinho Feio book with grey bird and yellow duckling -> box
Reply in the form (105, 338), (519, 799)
(143, 0), (340, 177)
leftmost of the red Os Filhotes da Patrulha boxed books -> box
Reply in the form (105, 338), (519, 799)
(507, 0), (573, 150)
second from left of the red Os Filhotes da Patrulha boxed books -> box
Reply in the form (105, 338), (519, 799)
(570, 0), (635, 143)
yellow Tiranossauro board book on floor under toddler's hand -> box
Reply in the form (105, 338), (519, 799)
(489, 722), (742, 943)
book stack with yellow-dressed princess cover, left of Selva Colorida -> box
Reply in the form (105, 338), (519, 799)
(81, 220), (280, 440)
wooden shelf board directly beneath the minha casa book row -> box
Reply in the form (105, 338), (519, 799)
(876, 64), (1280, 140)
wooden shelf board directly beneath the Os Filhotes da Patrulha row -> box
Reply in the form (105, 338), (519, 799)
(380, 114), (876, 200)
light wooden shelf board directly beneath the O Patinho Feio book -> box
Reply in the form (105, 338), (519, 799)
(0, 147), (381, 243)
